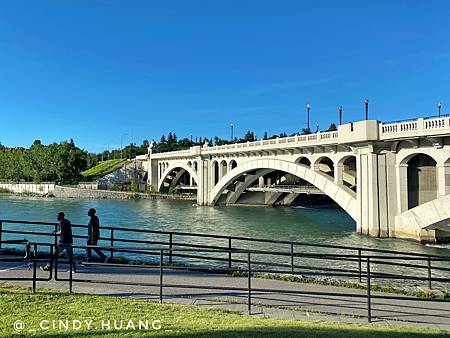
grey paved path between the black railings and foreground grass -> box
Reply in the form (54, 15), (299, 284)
(0, 256), (450, 329)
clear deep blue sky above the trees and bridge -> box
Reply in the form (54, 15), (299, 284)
(0, 0), (450, 151)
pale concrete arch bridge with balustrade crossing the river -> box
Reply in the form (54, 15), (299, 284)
(141, 117), (450, 242)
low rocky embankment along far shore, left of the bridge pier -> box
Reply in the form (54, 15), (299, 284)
(53, 185), (197, 201)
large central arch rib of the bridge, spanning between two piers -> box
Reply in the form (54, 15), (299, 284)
(209, 159), (358, 222)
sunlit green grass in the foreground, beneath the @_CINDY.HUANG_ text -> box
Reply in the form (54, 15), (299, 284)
(0, 285), (450, 338)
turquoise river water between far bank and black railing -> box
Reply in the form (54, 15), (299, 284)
(0, 195), (450, 288)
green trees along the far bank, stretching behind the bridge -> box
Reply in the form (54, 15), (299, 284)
(0, 123), (337, 184)
